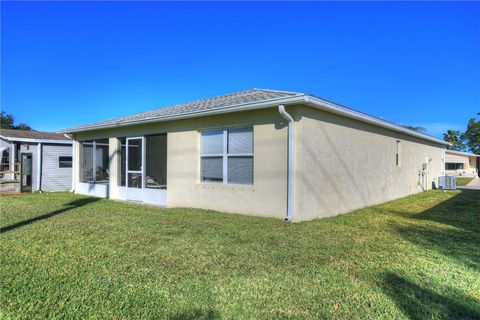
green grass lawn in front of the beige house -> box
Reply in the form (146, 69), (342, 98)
(0, 190), (480, 319)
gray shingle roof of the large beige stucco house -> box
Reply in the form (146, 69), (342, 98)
(62, 89), (303, 132)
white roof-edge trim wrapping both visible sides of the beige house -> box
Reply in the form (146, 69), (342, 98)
(59, 94), (451, 146)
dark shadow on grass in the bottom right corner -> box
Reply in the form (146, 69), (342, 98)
(383, 273), (480, 320)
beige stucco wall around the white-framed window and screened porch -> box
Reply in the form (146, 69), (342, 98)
(75, 109), (287, 218)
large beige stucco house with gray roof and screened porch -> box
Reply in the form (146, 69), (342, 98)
(63, 89), (449, 221)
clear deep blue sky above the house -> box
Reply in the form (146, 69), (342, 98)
(1, 1), (480, 137)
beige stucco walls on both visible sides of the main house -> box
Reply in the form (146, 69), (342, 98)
(75, 106), (443, 221)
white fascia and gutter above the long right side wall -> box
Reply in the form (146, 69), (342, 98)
(305, 95), (451, 146)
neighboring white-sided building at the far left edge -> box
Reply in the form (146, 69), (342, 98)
(0, 129), (72, 192)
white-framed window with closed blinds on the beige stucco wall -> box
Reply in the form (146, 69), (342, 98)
(200, 127), (253, 185)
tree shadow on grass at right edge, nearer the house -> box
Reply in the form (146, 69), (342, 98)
(393, 190), (480, 269)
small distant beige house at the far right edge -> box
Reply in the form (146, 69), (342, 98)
(445, 150), (480, 177)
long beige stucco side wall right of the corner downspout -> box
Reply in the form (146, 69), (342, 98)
(294, 107), (443, 221)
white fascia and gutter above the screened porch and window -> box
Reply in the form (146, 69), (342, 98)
(58, 95), (304, 133)
